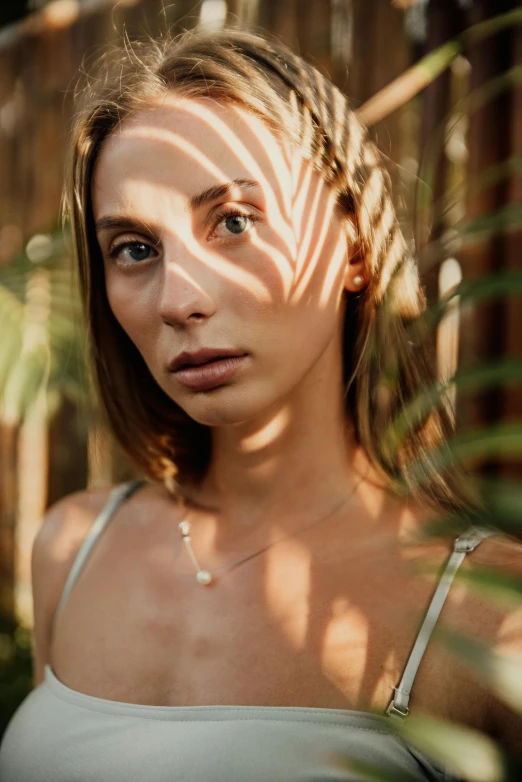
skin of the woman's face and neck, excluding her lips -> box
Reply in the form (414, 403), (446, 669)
(93, 95), (378, 545)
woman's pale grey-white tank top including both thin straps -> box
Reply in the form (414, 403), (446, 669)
(0, 481), (491, 782)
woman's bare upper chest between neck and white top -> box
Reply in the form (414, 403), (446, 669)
(51, 528), (484, 728)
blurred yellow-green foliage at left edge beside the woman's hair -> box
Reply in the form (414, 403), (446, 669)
(0, 231), (90, 424)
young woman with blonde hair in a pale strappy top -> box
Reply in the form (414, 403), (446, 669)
(0, 24), (520, 782)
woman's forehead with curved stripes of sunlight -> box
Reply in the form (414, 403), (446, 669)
(93, 94), (292, 213)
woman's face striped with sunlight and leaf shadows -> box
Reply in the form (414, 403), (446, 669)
(92, 99), (348, 426)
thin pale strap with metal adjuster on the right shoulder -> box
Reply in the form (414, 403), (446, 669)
(386, 527), (495, 719)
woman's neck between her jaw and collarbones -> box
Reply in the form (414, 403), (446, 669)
(185, 334), (384, 538)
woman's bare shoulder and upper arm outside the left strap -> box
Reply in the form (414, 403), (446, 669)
(31, 489), (109, 686)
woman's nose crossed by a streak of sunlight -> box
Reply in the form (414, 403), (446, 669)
(158, 246), (216, 327)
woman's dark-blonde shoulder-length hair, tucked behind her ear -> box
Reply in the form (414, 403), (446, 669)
(66, 29), (468, 507)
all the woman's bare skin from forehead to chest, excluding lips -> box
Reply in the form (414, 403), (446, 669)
(41, 93), (519, 752)
